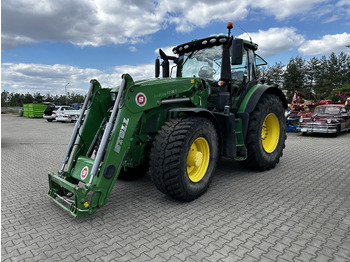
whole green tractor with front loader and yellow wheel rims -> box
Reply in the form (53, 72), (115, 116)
(48, 23), (287, 217)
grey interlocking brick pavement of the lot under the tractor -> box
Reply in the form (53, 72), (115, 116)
(1, 115), (350, 262)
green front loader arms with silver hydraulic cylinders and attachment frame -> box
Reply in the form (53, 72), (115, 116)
(48, 75), (142, 217)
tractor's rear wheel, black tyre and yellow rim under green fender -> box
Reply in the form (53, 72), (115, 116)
(240, 94), (287, 171)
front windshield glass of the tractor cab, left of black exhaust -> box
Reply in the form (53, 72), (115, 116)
(179, 46), (222, 81)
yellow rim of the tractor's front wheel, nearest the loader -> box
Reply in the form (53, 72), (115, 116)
(187, 137), (210, 182)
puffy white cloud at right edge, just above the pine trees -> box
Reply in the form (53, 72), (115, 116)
(298, 32), (350, 55)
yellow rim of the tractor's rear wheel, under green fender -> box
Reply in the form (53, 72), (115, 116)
(261, 113), (280, 153)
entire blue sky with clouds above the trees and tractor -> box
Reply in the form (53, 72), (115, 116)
(1, 0), (350, 95)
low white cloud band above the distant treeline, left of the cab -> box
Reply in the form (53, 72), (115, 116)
(1, 63), (154, 95)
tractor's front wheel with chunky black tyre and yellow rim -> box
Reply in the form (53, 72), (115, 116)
(150, 117), (218, 202)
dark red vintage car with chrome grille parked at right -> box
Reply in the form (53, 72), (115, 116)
(296, 104), (350, 136)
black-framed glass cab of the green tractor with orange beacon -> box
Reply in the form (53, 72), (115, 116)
(156, 22), (266, 111)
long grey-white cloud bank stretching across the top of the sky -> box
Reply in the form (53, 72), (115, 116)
(2, 0), (338, 49)
